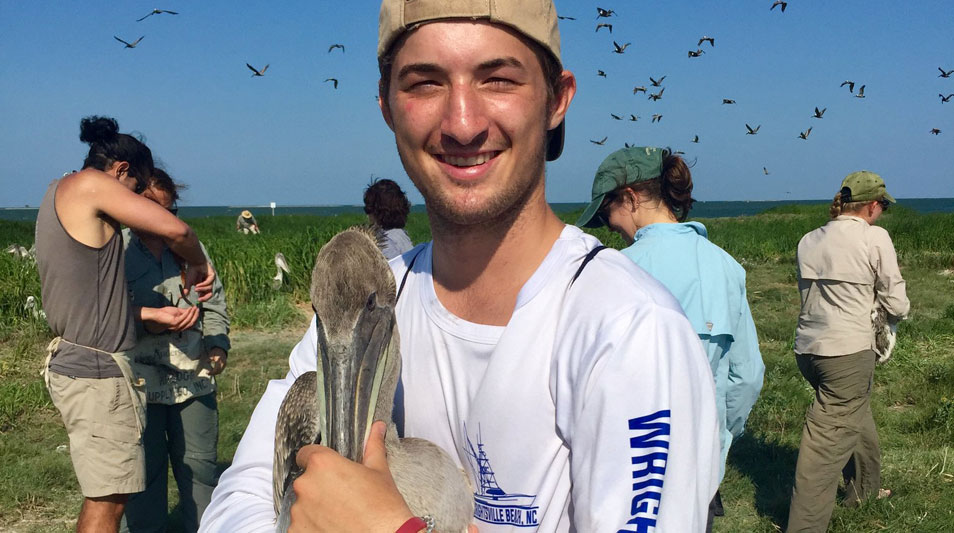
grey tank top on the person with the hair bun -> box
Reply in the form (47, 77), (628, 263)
(36, 180), (136, 378)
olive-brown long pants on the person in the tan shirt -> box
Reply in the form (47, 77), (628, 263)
(786, 350), (881, 533)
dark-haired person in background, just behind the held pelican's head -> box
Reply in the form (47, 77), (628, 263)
(364, 179), (414, 259)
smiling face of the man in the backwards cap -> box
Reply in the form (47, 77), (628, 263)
(381, 21), (575, 226)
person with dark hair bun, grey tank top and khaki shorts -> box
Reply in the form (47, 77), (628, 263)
(36, 117), (215, 532)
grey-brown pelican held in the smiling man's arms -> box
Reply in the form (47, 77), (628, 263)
(272, 228), (474, 532)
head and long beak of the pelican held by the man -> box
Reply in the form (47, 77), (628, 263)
(311, 225), (401, 462)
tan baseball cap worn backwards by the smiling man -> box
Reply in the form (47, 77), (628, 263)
(378, 0), (566, 161)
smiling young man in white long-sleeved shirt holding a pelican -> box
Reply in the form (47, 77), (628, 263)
(202, 0), (719, 533)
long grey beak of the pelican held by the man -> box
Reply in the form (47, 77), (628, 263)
(318, 293), (394, 462)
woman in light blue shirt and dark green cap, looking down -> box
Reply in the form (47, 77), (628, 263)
(576, 147), (765, 529)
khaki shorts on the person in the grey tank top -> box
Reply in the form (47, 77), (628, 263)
(49, 372), (146, 498)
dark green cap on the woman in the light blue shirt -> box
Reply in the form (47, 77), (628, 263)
(576, 146), (670, 228)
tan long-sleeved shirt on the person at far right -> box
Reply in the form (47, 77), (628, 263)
(795, 215), (911, 356)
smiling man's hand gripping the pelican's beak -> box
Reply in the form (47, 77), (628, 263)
(288, 421), (413, 533)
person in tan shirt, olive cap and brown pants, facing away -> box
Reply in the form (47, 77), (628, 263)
(786, 170), (911, 532)
